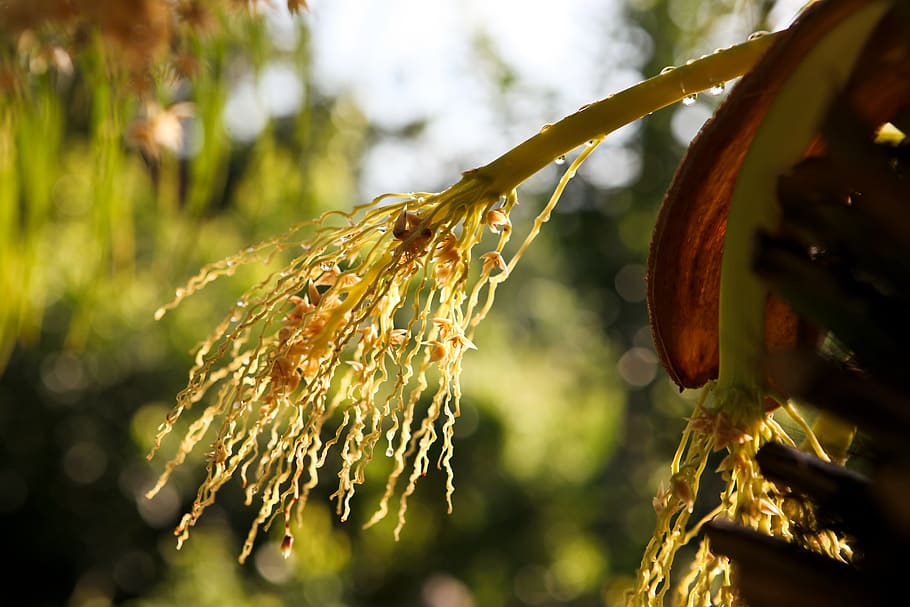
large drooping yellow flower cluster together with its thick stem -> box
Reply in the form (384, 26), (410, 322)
(148, 30), (774, 561)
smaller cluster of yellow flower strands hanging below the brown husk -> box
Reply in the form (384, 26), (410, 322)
(626, 382), (851, 606)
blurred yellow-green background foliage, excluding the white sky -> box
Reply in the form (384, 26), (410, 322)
(0, 0), (768, 607)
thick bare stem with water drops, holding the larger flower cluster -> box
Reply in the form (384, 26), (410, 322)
(474, 34), (777, 197)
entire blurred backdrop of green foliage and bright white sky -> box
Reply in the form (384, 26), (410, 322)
(0, 0), (799, 607)
